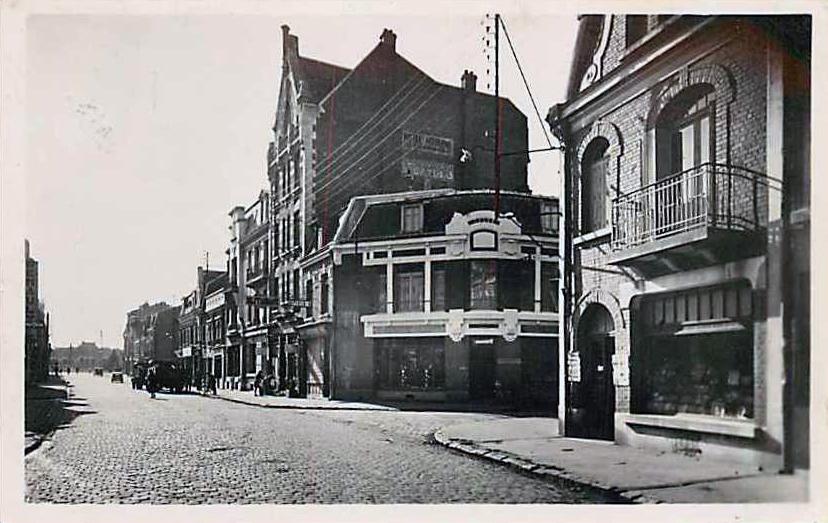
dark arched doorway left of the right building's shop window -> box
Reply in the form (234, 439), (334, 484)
(578, 305), (615, 440)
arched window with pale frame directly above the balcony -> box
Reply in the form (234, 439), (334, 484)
(656, 84), (714, 180)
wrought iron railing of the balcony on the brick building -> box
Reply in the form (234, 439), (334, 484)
(612, 163), (769, 251)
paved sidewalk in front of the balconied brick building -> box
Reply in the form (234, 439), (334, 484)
(435, 418), (808, 503)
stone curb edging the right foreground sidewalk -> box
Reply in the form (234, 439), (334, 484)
(434, 430), (648, 504)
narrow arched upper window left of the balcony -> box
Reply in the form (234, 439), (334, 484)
(581, 137), (609, 233)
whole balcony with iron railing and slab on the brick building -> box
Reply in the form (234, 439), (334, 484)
(609, 164), (769, 277)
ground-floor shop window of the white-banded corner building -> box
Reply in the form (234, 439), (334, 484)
(375, 338), (445, 390)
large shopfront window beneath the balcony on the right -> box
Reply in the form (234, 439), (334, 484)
(631, 282), (754, 419)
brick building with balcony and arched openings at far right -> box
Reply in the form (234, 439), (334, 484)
(549, 15), (811, 469)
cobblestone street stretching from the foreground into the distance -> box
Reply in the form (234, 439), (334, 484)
(26, 374), (605, 503)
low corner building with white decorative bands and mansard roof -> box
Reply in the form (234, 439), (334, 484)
(320, 189), (559, 404)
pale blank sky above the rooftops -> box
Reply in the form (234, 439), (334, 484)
(25, 11), (577, 347)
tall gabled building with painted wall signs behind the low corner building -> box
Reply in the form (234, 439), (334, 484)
(268, 25), (529, 395)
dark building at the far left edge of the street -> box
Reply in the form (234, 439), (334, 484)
(24, 240), (51, 384)
